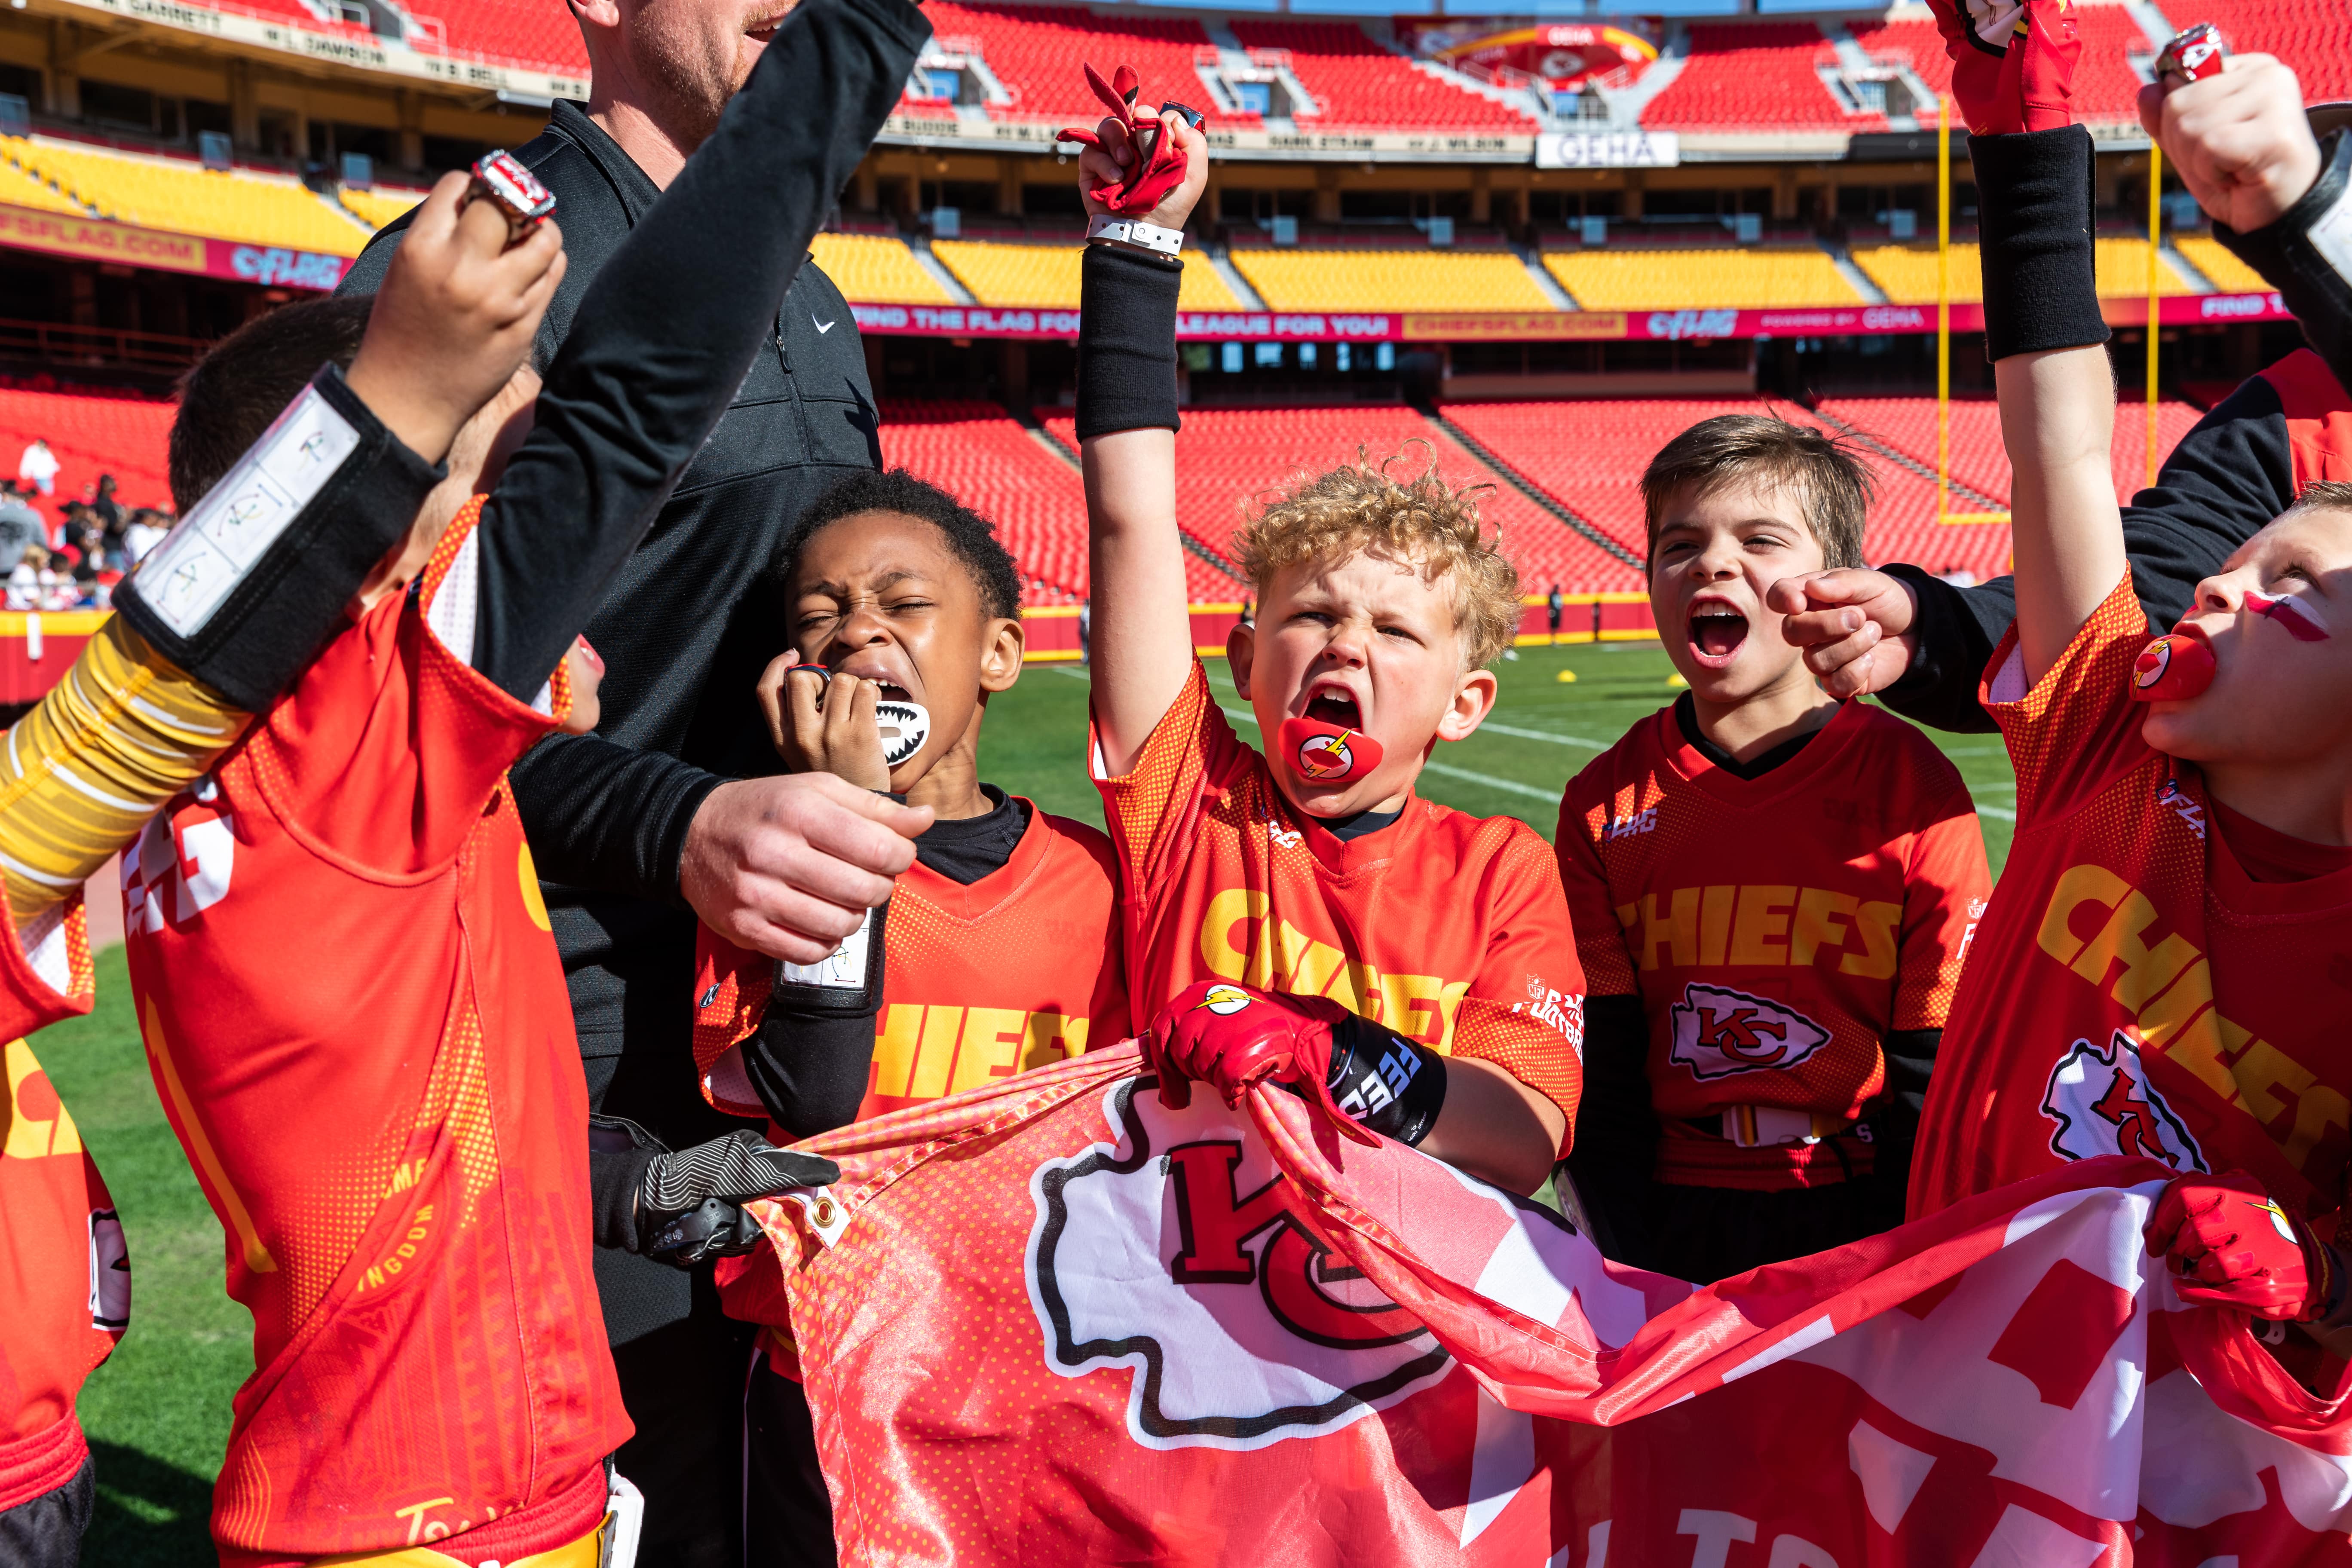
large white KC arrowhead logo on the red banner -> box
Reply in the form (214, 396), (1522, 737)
(1028, 1077), (1454, 1448)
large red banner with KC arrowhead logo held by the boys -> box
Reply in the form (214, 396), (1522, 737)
(727, 1046), (2352, 1568)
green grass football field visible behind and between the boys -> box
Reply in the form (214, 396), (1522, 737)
(35, 642), (2016, 1568)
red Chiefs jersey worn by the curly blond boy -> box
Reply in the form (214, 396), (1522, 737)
(1091, 661), (1585, 1152)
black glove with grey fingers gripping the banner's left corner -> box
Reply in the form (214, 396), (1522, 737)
(588, 1117), (842, 1269)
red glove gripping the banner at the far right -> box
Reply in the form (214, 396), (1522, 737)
(2145, 1171), (2338, 1323)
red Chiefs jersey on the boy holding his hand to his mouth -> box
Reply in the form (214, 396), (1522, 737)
(694, 802), (1131, 1138)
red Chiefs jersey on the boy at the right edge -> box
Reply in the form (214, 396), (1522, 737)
(1910, 576), (2352, 1234)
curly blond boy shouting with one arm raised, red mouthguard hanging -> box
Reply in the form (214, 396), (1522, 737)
(1077, 113), (1585, 1192)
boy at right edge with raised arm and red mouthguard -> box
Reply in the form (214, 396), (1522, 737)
(1912, 0), (2352, 1363)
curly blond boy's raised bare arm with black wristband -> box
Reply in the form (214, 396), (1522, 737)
(1077, 113), (1209, 776)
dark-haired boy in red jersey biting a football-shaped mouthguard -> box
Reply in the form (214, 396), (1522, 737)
(696, 470), (1131, 1563)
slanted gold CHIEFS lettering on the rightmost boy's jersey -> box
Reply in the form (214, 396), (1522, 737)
(2037, 865), (2352, 1171)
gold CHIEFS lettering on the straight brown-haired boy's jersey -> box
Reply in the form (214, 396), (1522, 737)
(1616, 884), (1903, 980)
